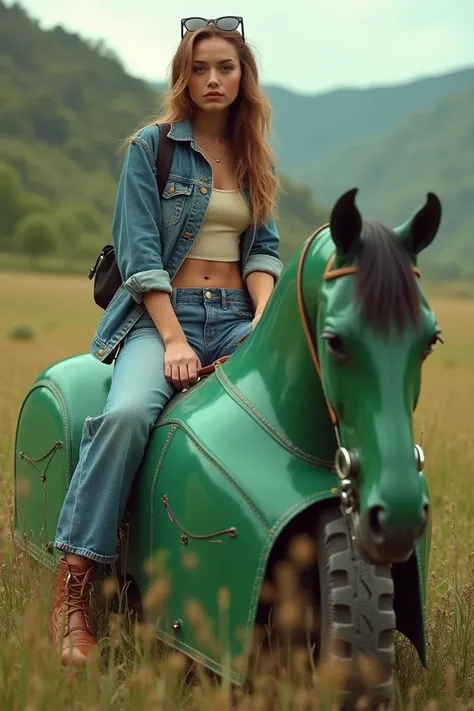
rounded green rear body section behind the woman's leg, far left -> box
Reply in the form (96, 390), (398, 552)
(14, 354), (112, 565)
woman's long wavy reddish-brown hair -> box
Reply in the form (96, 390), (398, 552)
(136, 27), (279, 225)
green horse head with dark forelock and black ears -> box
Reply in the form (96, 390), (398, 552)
(298, 189), (441, 563)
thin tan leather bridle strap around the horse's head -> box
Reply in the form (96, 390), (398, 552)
(296, 223), (421, 434)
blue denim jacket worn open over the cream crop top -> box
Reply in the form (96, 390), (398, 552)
(90, 120), (283, 363)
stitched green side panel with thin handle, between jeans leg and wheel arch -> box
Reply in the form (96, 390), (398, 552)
(130, 427), (268, 680)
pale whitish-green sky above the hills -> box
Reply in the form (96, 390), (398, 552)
(7, 0), (474, 93)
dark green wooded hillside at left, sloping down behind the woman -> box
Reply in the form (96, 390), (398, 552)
(0, 1), (327, 270)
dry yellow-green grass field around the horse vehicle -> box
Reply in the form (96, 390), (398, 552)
(0, 273), (474, 711)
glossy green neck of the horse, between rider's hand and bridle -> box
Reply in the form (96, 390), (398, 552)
(218, 234), (337, 463)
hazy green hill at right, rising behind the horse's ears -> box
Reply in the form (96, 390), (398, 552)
(299, 88), (474, 277)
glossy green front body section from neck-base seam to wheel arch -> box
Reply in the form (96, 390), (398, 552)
(122, 376), (337, 683)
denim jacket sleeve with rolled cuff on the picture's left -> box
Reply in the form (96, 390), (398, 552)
(112, 136), (171, 304)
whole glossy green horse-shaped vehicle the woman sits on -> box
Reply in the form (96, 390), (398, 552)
(15, 189), (441, 709)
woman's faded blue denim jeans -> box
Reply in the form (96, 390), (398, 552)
(55, 289), (253, 563)
